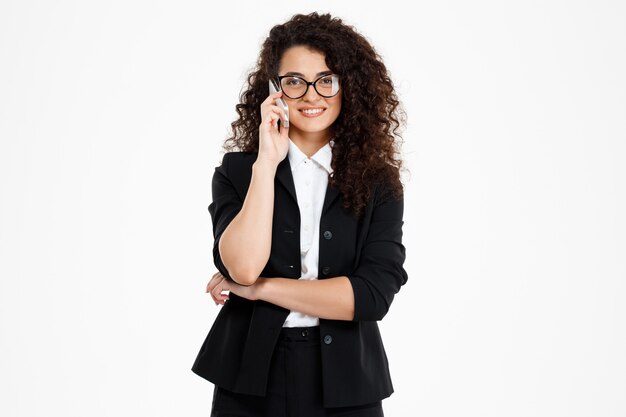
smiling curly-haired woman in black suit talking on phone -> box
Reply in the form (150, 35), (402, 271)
(192, 13), (407, 417)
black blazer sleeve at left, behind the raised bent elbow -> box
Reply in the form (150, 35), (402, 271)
(209, 153), (243, 278)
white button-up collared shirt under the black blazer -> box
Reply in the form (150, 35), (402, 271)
(283, 138), (334, 327)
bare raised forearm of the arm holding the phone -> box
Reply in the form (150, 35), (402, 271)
(219, 158), (277, 285)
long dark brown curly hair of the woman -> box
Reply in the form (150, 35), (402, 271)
(223, 12), (406, 216)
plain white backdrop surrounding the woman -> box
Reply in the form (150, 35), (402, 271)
(0, 0), (626, 417)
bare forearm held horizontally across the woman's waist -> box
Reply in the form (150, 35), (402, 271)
(252, 276), (354, 320)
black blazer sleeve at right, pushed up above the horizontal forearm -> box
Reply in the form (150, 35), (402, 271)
(348, 180), (408, 321)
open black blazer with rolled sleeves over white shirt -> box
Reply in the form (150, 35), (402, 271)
(191, 152), (408, 407)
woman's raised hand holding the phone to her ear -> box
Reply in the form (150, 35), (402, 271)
(257, 91), (289, 165)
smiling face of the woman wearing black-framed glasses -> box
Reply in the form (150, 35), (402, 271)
(278, 46), (341, 140)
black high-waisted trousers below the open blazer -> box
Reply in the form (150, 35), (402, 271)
(211, 326), (384, 417)
